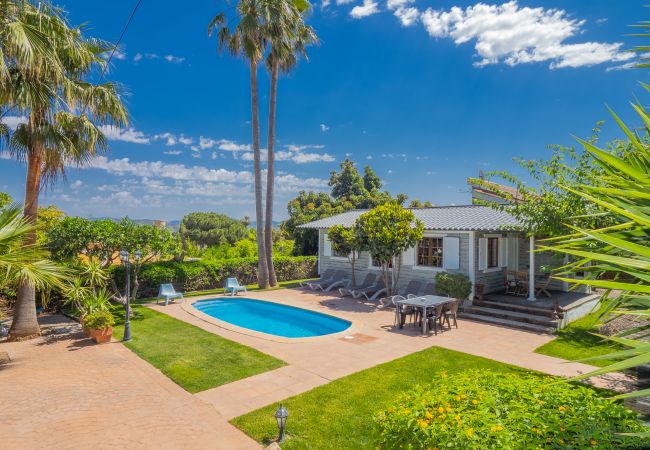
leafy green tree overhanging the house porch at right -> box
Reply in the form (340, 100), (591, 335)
(469, 127), (616, 236)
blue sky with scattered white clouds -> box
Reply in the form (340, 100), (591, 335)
(0, 0), (650, 220)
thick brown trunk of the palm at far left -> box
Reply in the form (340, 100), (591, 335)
(9, 123), (43, 340)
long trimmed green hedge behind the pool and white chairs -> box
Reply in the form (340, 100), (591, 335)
(111, 256), (317, 298)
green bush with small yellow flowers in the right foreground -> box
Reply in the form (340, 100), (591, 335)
(375, 370), (647, 449)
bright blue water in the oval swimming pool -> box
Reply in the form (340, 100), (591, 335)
(192, 297), (352, 338)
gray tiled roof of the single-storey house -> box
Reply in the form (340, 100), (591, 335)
(300, 205), (520, 231)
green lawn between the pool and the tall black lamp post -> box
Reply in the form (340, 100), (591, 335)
(113, 304), (285, 393)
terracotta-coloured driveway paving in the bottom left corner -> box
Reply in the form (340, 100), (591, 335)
(0, 316), (260, 450)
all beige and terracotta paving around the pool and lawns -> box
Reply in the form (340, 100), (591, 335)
(0, 290), (629, 449)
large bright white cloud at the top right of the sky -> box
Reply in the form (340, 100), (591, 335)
(420, 1), (632, 68)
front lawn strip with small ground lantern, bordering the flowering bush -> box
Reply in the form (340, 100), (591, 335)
(231, 347), (522, 449)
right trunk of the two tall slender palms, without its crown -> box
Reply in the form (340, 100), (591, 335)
(264, 61), (279, 286)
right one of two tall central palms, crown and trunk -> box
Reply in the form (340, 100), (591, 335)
(264, 0), (317, 286)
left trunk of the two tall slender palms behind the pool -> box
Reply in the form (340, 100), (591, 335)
(251, 61), (269, 289)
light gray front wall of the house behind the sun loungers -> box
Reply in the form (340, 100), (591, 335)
(318, 230), (470, 291)
